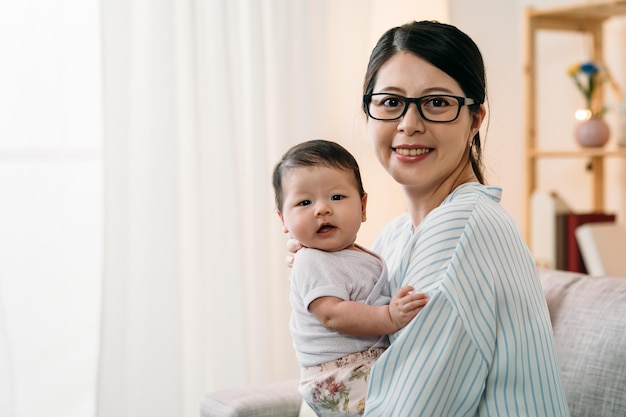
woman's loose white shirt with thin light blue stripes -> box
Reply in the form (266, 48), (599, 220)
(365, 183), (569, 417)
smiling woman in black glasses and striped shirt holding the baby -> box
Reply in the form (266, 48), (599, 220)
(363, 21), (569, 416)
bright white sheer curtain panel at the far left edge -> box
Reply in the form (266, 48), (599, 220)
(0, 0), (103, 417)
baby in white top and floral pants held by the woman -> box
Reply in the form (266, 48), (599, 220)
(273, 140), (427, 416)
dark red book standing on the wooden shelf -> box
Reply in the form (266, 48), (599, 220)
(557, 212), (615, 273)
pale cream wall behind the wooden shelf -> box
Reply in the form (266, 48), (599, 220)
(449, 0), (626, 234)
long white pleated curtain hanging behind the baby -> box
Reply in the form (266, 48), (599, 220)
(98, 0), (445, 417)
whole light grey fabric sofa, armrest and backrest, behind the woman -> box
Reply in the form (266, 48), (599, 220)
(201, 268), (626, 417)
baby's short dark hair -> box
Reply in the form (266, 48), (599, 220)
(272, 139), (365, 210)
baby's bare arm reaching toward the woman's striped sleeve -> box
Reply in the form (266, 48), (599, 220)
(309, 286), (428, 336)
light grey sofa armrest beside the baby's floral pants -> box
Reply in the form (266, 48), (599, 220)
(201, 379), (302, 417)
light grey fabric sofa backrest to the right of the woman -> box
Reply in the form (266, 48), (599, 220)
(539, 270), (626, 417)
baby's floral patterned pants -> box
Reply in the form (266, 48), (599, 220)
(300, 348), (385, 417)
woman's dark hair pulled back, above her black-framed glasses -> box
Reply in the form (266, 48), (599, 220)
(363, 21), (487, 184)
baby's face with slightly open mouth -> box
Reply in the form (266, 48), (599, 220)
(278, 166), (367, 251)
